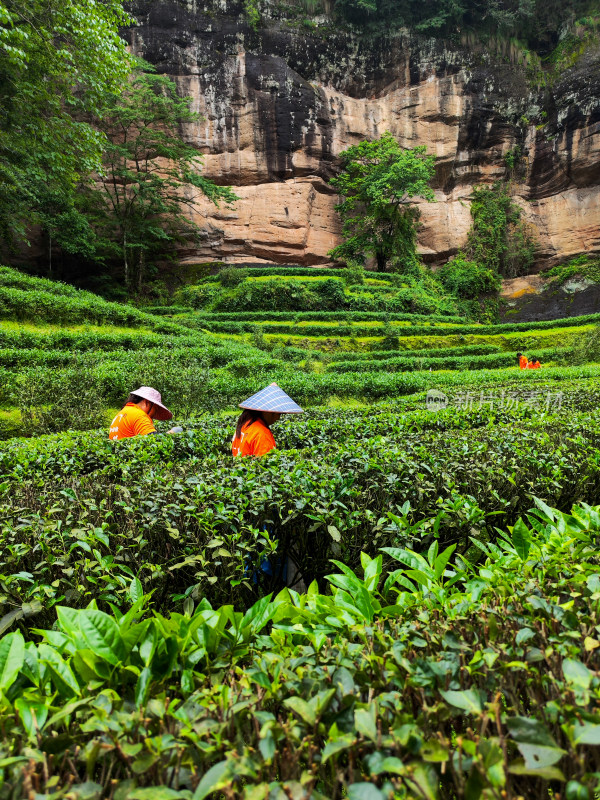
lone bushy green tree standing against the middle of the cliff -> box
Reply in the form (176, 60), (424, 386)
(329, 133), (435, 271)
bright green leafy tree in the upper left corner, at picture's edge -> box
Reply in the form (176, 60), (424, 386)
(0, 0), (132, 250)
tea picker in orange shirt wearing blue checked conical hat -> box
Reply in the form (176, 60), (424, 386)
(231, 383), (303, 456)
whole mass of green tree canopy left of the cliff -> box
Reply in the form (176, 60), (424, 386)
(0, 0), (236, 296)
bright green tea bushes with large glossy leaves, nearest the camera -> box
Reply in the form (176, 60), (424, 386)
(0, 502), (600, 800)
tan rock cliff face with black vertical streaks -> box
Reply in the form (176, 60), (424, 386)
(128, 0), (600, 270)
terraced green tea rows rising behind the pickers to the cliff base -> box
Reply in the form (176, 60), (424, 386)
(0, 268), (600, 436)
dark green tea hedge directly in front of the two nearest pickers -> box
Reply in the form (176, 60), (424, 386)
(0, 404), (600, 614)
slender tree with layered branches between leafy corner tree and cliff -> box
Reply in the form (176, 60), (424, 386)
(88, 64), (237, 289)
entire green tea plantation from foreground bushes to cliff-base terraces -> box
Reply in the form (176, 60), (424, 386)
(0, 269), (600, 800)
